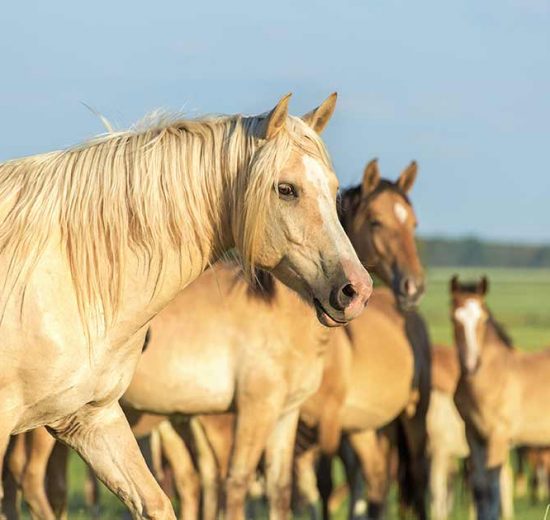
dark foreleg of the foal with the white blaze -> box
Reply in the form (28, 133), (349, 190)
(466, 426), (500, 520)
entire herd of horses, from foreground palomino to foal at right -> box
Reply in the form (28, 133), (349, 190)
(0, 94), (550, 520)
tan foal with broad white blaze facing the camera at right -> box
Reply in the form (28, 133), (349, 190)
(450, 276), (550, 520)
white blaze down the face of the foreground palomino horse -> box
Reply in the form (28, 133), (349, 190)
(302, 155), (351, 257)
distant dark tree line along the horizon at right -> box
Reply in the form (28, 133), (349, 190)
(418, 238), (550, 268)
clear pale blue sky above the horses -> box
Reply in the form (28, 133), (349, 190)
(0, 0), (550, 243)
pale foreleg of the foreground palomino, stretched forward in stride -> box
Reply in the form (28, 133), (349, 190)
(50, 402), (175, 520)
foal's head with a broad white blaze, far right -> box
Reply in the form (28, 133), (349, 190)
(450, 275), (491, 374)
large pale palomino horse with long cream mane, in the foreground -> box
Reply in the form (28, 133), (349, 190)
(0, 95), (371, 518)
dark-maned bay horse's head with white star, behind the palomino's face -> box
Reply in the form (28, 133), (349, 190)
(341, 159), (424, 309)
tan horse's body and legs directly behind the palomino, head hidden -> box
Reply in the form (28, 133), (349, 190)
(0, 153), (384, 517)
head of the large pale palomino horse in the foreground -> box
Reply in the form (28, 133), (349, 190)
(247, 95), (372, 326)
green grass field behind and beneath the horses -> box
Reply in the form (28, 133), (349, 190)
(20, 268), (550, 520)
